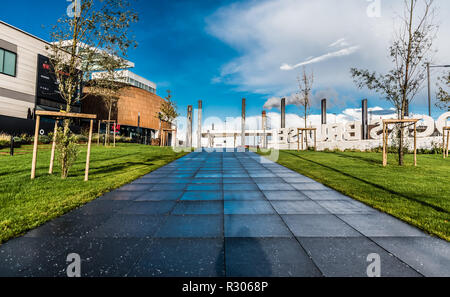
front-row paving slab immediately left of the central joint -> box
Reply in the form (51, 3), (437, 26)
(127, 238), (225, 277)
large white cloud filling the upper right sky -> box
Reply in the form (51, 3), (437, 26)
(206, 0), (450, 106)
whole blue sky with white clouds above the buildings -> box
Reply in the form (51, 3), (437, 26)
(0, 0), (450, 119)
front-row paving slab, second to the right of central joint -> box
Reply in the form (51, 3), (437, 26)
(299, 237), (421, 277)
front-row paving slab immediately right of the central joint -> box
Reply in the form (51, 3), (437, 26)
(225, 238), (322, 277)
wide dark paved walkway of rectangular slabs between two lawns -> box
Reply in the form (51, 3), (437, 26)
(0, 152), (450, 277)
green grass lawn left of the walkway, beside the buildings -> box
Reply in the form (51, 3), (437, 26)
(0, 144), (185, 243)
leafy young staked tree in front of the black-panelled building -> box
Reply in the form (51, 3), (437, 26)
(49, 0), (138, 178)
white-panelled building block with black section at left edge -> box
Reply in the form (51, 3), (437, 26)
(0, 21), (81, 134)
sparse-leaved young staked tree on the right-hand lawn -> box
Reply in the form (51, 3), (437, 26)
(351, 0), (437, 165)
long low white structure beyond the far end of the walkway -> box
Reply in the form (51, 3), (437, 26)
(188, 112), (450, 151)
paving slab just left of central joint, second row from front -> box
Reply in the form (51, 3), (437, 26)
(155, 215), (223, 238)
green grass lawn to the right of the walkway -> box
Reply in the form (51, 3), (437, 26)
(258, 151), (450, 241)
